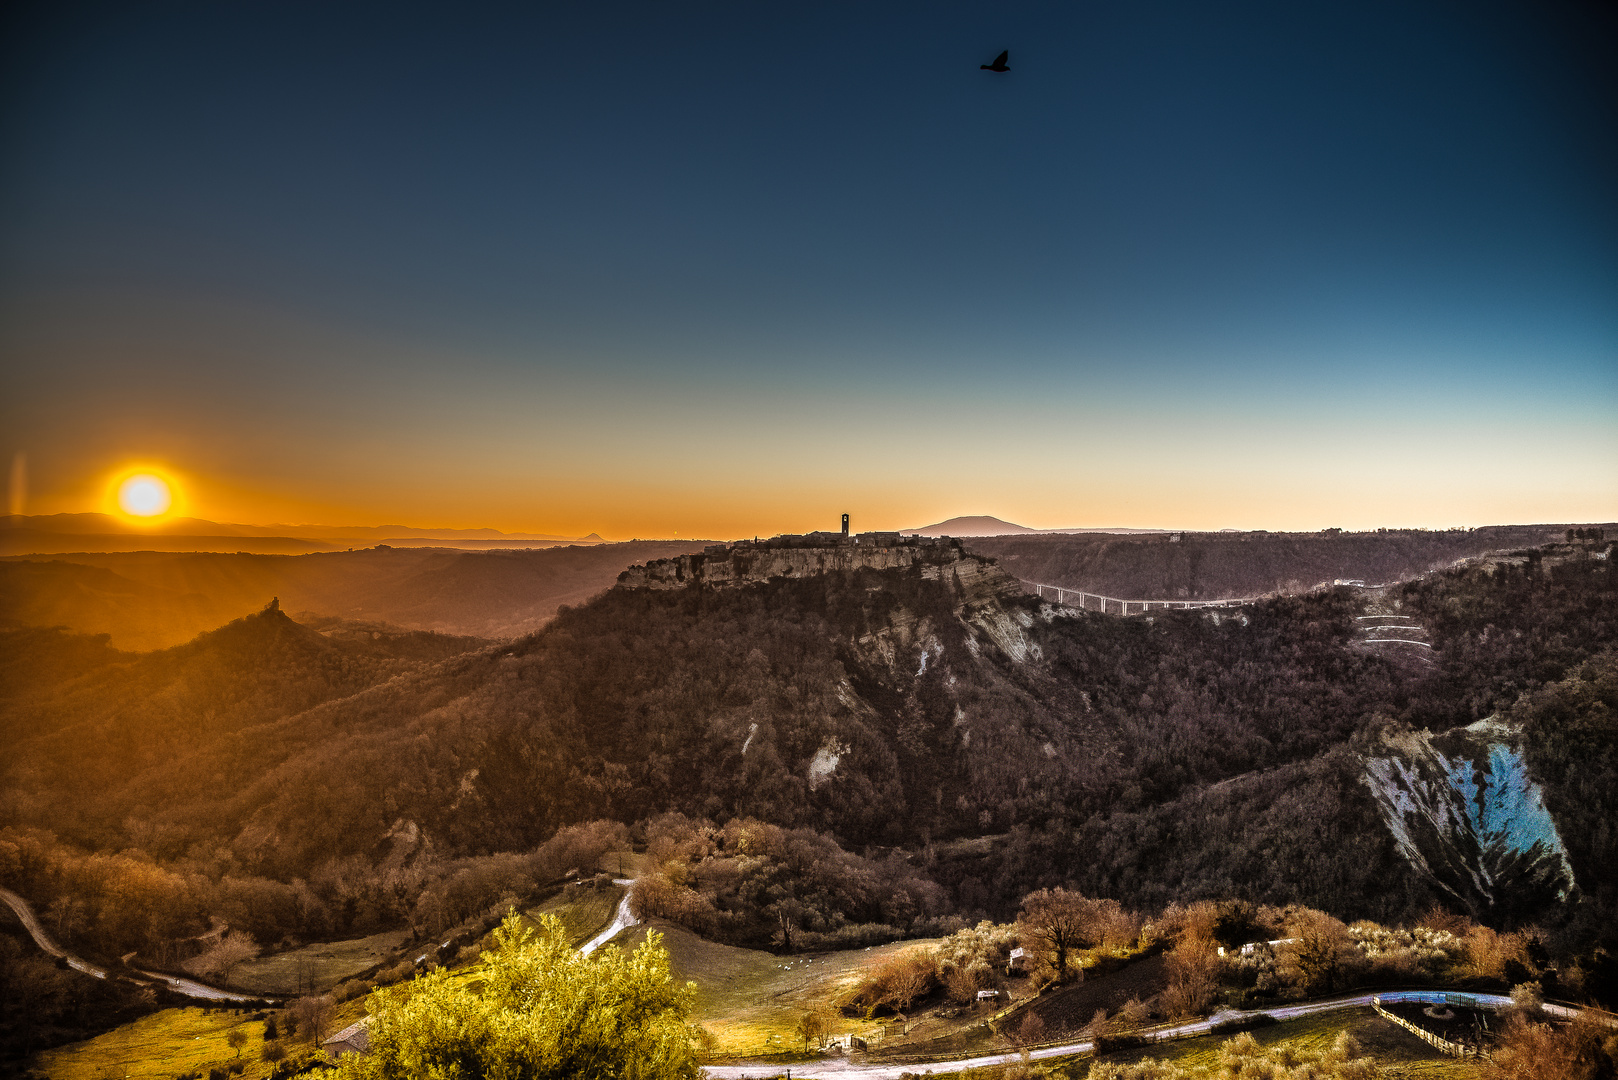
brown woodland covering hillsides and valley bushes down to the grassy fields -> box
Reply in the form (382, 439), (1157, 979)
(0, 542), (1618, 1059)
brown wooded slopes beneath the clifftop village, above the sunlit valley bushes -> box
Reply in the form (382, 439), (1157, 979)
(0, 546), (1618, 977)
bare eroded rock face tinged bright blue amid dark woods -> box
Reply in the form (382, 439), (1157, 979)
(1366, 717), (1574, 915)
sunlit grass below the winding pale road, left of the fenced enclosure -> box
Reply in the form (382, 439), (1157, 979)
(1069, 1009), (1484, 1080)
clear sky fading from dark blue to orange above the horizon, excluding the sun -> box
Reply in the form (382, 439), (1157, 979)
(0, 0), (1618, 538)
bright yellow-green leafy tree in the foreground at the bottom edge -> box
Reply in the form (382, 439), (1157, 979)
(341, 915), (697, 1080)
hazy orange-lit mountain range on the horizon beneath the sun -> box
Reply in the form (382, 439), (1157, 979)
(0, 513), (605, 555)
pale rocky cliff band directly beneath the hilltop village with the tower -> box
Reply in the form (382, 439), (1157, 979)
(618, 536), (1023, 601)
